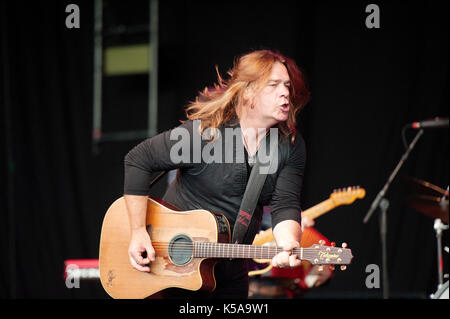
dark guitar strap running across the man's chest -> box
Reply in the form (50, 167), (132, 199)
(231, 136), (278, 244)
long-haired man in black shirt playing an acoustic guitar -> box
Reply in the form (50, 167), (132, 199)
(124, 50), (309, 298)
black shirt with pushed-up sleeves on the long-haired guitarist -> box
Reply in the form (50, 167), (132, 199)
(124, 120), (306, 242)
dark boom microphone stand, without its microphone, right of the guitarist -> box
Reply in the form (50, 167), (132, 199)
(363, 129), (423, 299)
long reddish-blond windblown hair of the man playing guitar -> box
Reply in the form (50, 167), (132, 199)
(186, 50), (310, 142)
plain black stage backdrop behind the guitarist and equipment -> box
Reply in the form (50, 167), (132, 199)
(0, 0), (449, 298)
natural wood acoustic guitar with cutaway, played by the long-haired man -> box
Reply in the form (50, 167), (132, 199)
(99, 197), (353, 299)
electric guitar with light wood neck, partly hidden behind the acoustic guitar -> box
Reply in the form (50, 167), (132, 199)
(248, 186), (366, 276)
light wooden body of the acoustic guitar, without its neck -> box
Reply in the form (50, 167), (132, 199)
(99, 197), (230, 299)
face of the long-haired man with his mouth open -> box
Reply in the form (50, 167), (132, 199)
(254, 62), (291, 125)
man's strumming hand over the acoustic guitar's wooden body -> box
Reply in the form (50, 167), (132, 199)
(128, 228), (155, 272)
